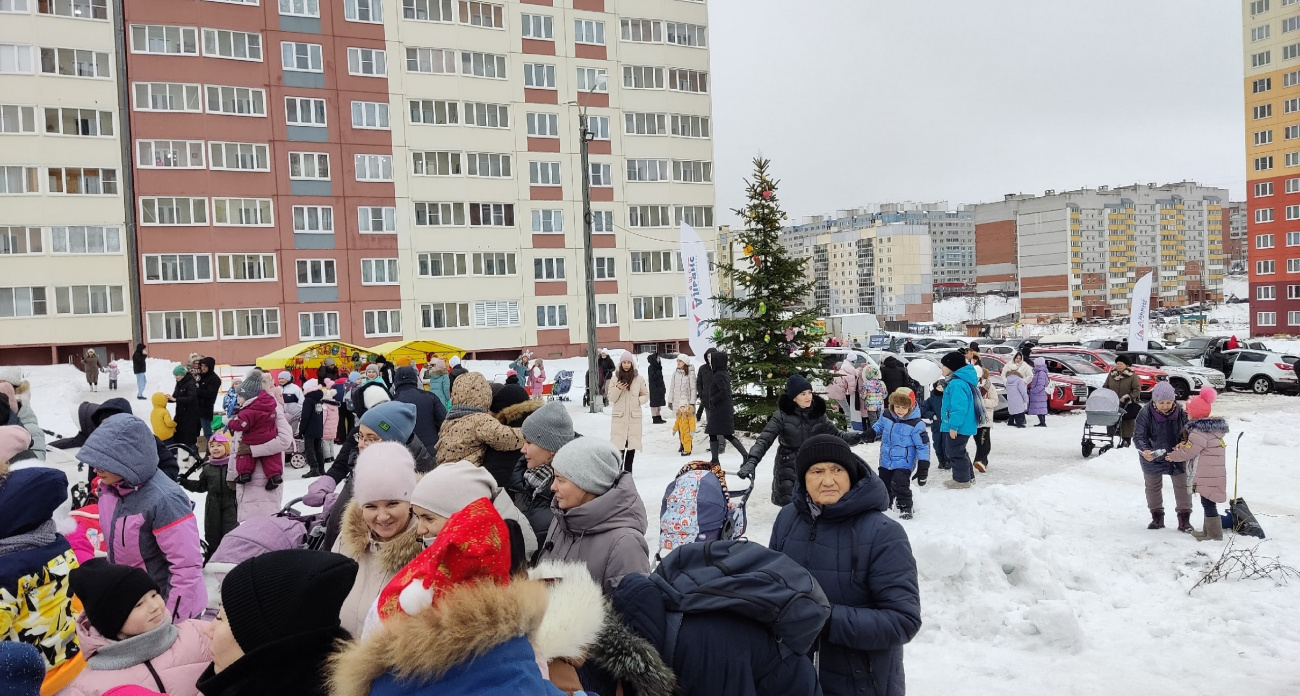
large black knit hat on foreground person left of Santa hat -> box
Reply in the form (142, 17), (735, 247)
(221, 549), (358, 653)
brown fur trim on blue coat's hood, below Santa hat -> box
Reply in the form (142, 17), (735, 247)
(328, 580), (547, 696)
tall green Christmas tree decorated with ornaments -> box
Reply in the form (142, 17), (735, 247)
(714, 157), (826, 431)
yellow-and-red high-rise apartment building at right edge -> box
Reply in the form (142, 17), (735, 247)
(1242, 0), (1300, 336)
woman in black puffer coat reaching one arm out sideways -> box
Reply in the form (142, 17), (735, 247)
(737, 375), (875, 507)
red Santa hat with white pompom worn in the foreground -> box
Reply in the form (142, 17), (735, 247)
(378, 498), (510, 621)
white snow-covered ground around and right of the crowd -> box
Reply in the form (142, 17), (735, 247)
(17, 359), (1300, 696)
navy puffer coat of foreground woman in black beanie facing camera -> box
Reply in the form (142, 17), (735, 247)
(768, 455), (925, 696)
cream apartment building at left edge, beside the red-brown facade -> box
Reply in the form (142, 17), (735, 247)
(0, 0), (135, 364)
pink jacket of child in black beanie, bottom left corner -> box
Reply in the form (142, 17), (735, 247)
(62, 611), (212, 696)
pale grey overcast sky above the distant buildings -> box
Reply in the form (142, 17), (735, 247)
(710, 0), (1245, 222)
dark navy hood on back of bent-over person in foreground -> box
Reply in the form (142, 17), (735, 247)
(650, 540), (831, 660)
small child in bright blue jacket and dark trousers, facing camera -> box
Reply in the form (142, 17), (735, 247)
(872, 389), (930, 519)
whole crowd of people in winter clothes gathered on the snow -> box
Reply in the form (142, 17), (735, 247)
(0, 338), (1227, 696)
